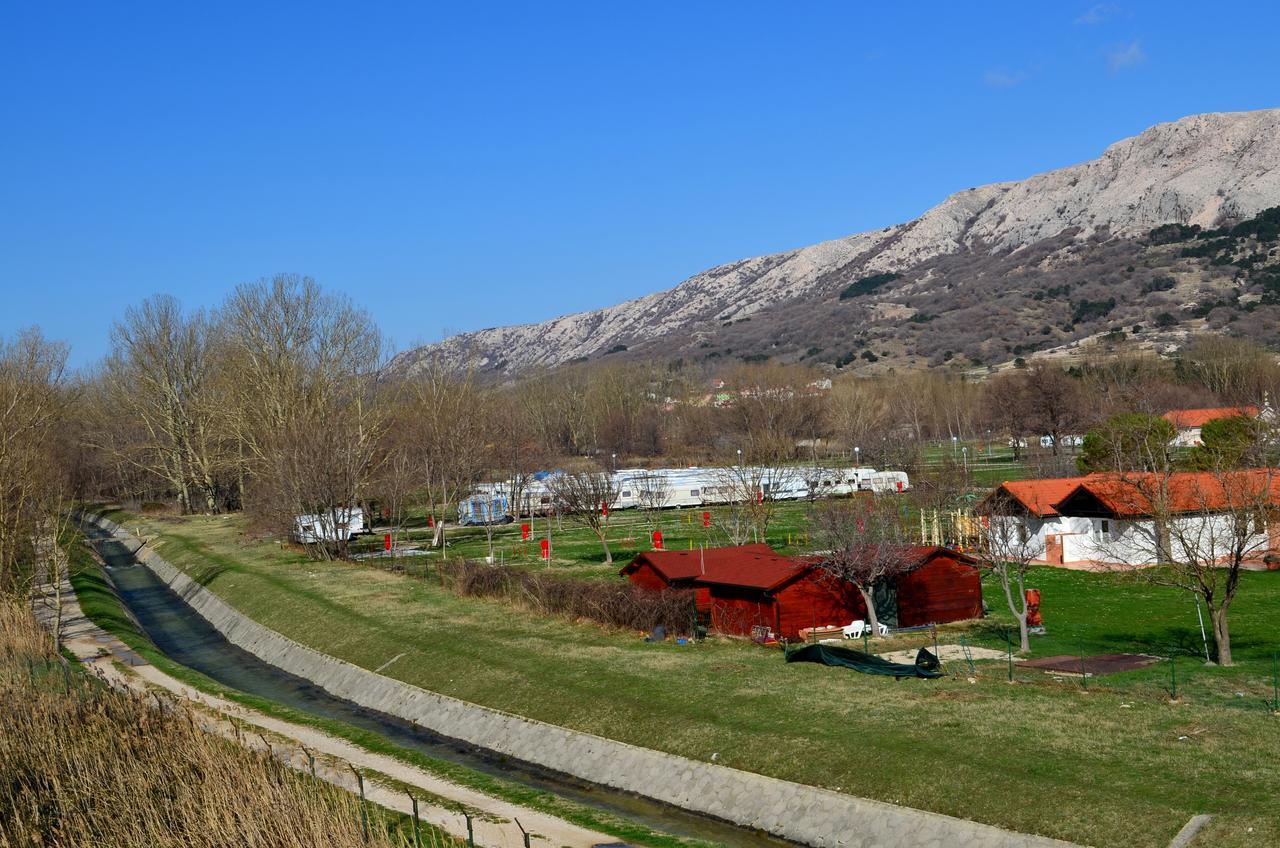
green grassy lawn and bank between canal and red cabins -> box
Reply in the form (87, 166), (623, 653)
(94, 516), (1280, 847)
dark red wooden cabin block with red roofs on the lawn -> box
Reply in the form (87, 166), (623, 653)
(622, 544), (982, 638)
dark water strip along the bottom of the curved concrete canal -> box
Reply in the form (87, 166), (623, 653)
(90, 529), (795, 848)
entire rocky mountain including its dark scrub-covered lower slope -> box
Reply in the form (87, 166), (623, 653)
(397, 109), (1280, 373)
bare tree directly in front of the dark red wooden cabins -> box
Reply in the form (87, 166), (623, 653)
(812, 498), (918, 634)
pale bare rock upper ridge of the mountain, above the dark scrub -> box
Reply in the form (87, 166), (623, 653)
(396, 109), (1280, 373)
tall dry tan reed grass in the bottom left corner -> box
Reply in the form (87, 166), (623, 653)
(0, 601), (450, 848)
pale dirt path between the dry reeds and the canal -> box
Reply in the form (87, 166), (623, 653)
(33, 582), (618, 848)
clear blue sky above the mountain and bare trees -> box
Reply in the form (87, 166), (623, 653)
(0, 0), (1280, 365)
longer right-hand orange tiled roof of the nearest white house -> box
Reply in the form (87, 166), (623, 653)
(1055, 469), (1280, 518)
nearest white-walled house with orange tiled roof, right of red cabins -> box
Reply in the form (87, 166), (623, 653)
(979, 469), (1280, 569)
